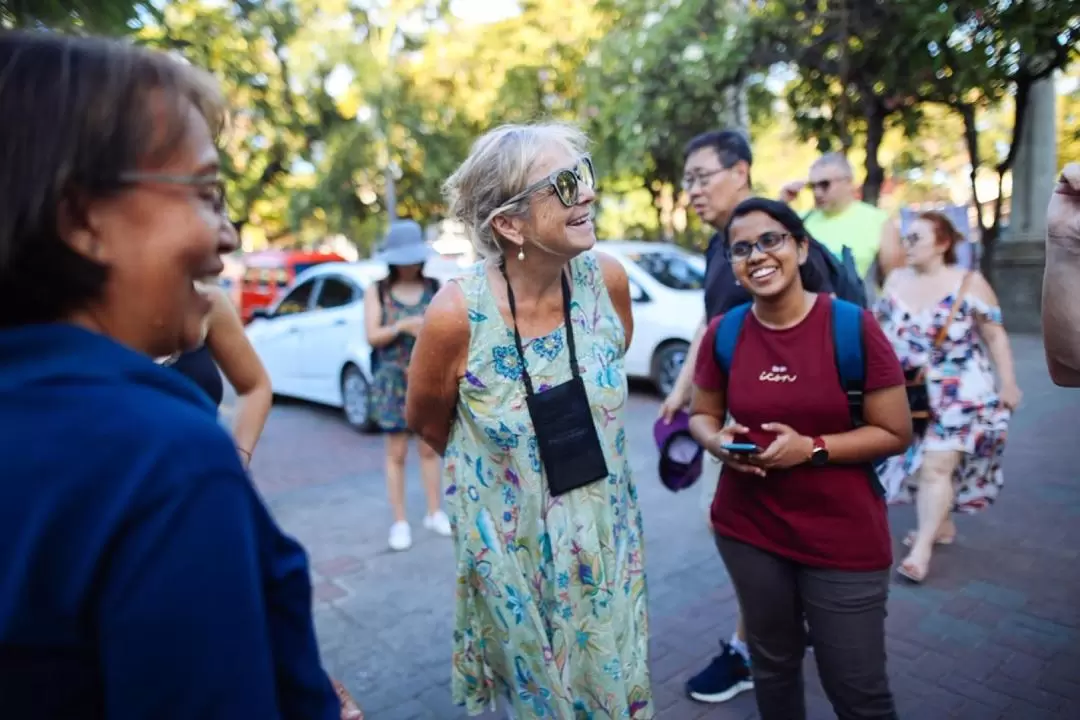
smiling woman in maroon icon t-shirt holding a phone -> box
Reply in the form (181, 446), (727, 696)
(690, 198), (912, 720)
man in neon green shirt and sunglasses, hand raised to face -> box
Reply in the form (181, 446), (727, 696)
(780, 152), (904, 285)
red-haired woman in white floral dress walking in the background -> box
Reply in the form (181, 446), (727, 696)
(875, 213), (1021, 583)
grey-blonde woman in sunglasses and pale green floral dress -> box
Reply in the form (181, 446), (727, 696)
(406, 124), (654, 720)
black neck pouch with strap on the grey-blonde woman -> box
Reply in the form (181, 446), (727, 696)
(500, 266), (608, 495)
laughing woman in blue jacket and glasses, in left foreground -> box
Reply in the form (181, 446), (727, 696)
(0, 33), (339, 720)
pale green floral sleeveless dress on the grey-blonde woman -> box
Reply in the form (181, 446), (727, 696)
(444, 253), (654, 720)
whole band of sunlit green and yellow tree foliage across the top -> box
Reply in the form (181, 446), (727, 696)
(21, 0), (1080, 259)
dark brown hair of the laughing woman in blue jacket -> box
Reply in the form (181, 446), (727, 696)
(0, 31), (225, 327)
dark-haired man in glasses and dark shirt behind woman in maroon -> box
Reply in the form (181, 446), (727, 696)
(660, 130), (833, 703)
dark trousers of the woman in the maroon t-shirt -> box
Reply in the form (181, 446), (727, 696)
(716, 536), (896, 720)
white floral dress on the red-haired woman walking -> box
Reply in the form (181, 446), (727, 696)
(874, 280), (1011, 513)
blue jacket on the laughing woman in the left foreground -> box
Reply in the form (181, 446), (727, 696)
(0, 324), (339, 720)
